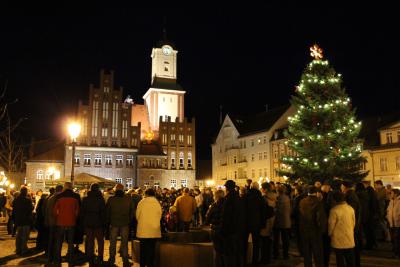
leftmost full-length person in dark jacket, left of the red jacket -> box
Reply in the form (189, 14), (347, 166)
(13, 187), (33, 255)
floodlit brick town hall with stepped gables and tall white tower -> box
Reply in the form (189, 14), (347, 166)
(26, 42), (196, 190)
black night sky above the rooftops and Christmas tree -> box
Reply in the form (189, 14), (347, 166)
(0, 6), (400, 158)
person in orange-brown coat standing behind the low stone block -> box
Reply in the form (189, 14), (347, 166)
(174, 188), (196, 232)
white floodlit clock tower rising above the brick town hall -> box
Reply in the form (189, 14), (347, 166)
(143, 40), (185, 133)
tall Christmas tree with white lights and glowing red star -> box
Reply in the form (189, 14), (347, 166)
(280, 45), (368, 184)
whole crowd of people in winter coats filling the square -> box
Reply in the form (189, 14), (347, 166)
(0, 179), (400, 267)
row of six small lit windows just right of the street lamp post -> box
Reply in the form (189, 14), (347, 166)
(74, 154), (133, 167)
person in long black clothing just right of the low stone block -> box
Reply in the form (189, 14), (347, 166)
(221, 180), (246, 267)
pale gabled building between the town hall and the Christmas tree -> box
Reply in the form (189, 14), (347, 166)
(211, 105), (294, 185)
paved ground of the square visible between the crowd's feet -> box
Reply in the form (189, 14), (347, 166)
(0, 224), (400, 267)
